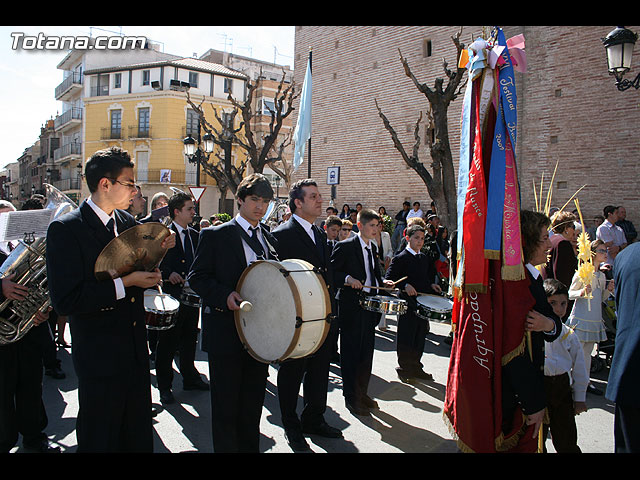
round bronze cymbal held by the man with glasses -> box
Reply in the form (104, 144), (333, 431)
(94, 222), (171, 280)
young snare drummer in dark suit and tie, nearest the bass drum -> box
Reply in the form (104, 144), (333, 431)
(331, 209), (391, 415)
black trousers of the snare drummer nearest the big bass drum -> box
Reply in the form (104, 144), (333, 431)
(338, 306), (380, 405)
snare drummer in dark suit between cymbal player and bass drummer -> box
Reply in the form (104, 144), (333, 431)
(156, 193), (209, 404)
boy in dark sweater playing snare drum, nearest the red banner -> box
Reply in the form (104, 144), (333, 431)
(385, 224), (442, 383)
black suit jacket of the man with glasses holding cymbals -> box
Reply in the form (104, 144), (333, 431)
(46, 201), (149, 378)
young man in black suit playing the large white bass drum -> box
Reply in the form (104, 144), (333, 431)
(187, 173), (277, 453)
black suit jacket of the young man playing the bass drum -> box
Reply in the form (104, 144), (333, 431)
(188, 218), (277, 355)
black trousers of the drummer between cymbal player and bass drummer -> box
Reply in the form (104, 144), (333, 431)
(156, 304), (200, 391)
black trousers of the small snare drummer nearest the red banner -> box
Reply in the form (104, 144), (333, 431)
(396, 308), (429, 374)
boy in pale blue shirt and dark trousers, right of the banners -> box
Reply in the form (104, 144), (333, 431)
(543, 279), (589, 453)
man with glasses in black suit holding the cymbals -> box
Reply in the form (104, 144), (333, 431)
(46, 147), (176, 452)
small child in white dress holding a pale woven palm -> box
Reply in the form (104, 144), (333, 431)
(567, 240), (613, 395)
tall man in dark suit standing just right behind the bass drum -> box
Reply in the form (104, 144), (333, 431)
(273, 179), (342, 452)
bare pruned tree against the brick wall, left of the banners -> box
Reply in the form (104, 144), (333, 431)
(375, 27), (466, 229)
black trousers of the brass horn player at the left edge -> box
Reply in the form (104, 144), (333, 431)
(0, 325), (48, 453)
